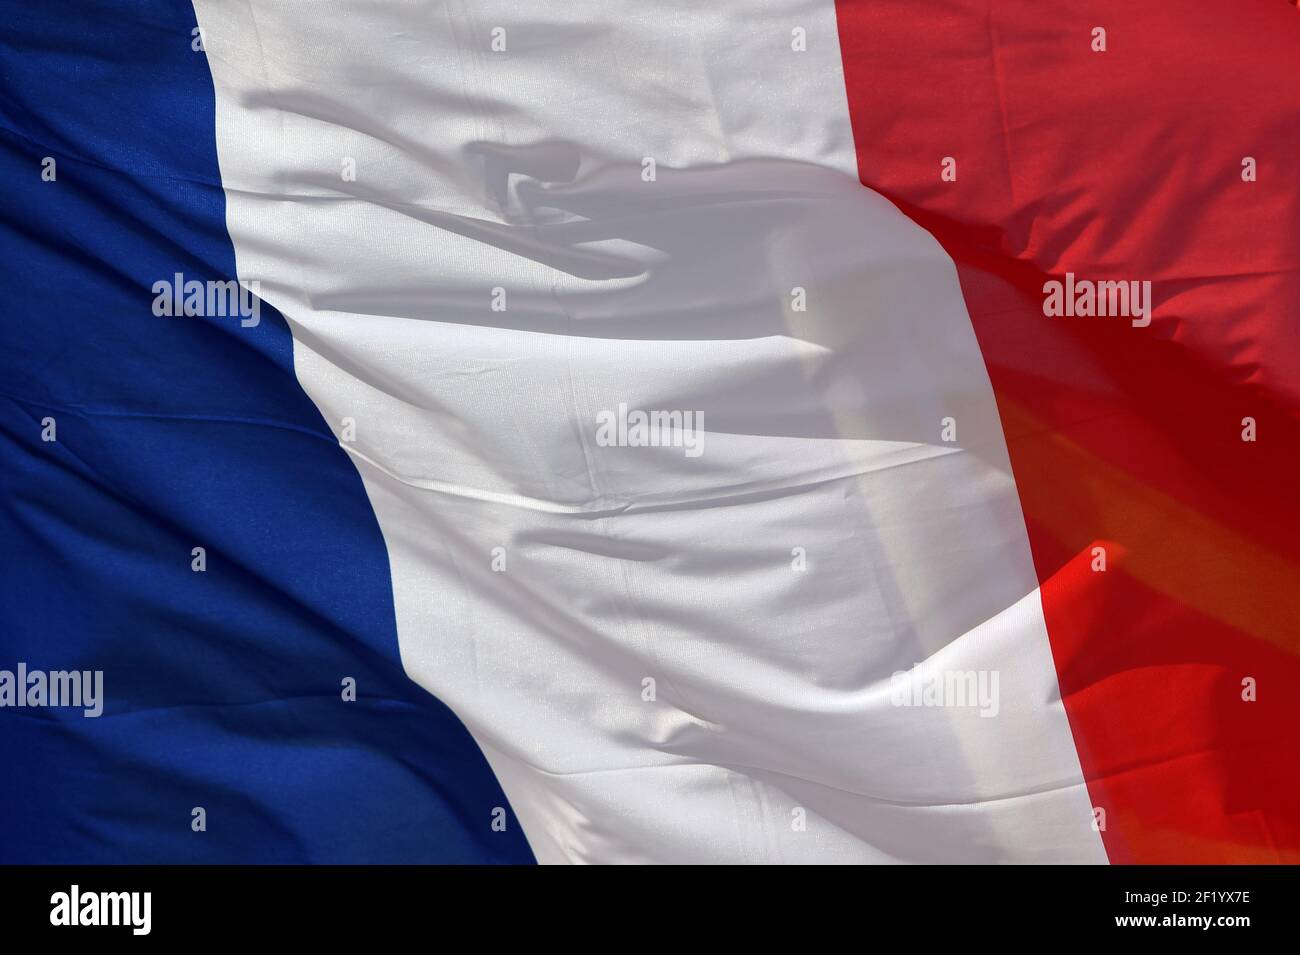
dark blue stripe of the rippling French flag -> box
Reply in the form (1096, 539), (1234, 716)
(0, 0), (532, 863)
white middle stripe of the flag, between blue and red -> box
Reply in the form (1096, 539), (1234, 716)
(195, 0), (1105, 861)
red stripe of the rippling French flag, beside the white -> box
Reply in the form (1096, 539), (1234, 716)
(837, 0), (1300, 863)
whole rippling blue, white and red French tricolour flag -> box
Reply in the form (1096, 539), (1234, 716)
(0, 0), (1300, 863)
